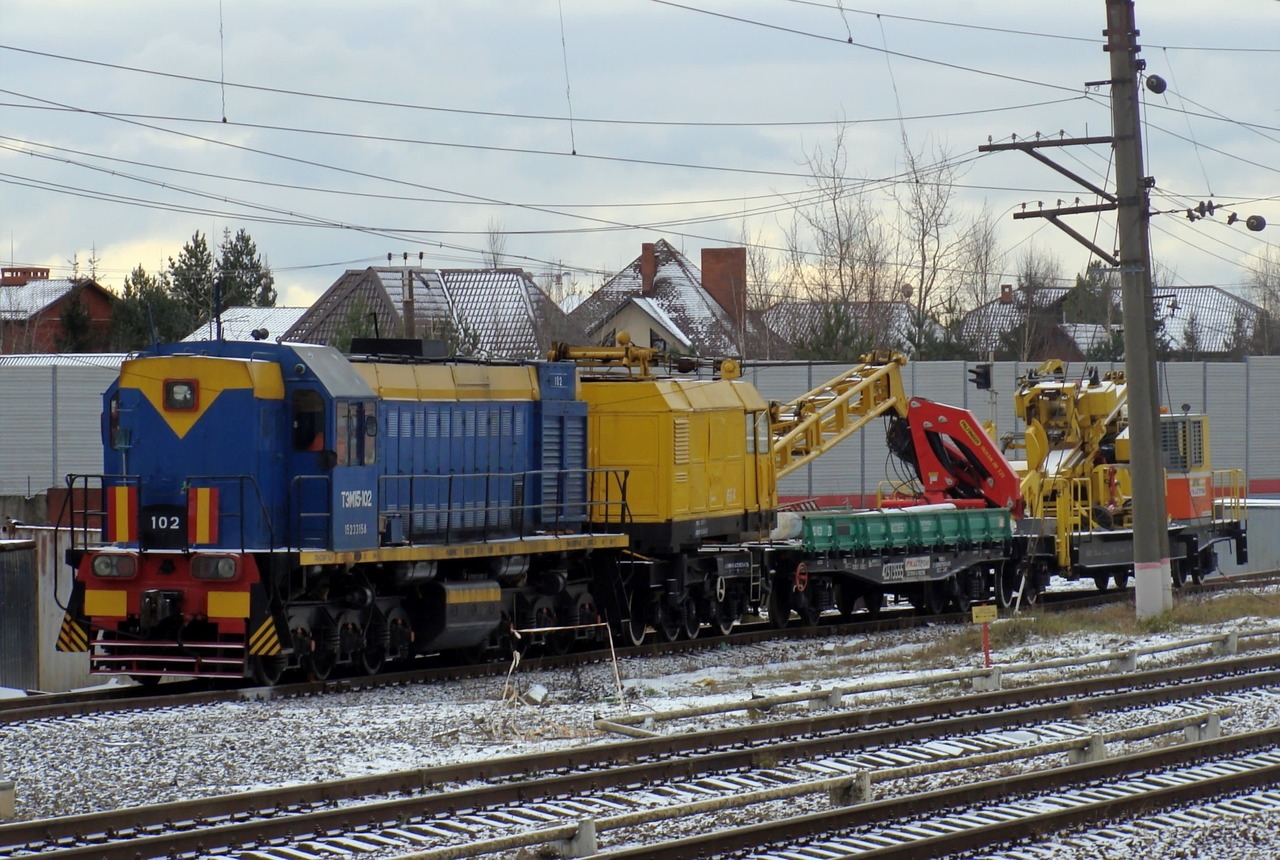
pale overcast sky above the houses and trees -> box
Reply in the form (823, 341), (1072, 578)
(0, 0), (1280, 305)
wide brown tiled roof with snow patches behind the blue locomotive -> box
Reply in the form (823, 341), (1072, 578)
(284, 266), (586, 358)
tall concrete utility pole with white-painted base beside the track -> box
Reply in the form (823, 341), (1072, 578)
(1103, 0), (1174, 618)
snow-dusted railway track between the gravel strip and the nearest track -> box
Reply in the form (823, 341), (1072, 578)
(0, 654), (1280, 860)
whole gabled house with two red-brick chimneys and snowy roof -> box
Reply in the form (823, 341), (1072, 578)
(570, 239), (791, 358)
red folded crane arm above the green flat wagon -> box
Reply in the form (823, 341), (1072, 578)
(888, 397), (1021, 516)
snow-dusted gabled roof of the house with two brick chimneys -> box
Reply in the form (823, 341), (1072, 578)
(570, 239), (788, 358)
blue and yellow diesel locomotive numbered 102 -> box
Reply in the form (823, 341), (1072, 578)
(60, 342), (645, 682)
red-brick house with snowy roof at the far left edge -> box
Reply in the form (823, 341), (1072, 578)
(0, 266), (115, 354)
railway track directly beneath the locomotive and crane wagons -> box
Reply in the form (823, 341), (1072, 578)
(0, 571), (1280, 724)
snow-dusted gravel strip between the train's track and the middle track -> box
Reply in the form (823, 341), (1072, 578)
(0, 593), (1280, 859)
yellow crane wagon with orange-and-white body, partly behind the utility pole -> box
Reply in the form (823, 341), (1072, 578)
(1002, 360), (1248, 589)
